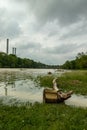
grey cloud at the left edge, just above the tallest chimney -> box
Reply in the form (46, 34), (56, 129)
(0, 9), (21, 38)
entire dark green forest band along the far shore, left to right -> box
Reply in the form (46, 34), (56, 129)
(0, 52), (87, 69)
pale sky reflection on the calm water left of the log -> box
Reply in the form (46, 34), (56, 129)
(0, 79), (43, 103)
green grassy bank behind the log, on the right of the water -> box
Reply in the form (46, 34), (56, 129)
(39, 70), (87, 95)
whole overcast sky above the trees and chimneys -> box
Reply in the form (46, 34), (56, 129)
(0, 0), (87, 65)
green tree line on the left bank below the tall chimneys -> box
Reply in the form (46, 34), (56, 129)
(0, 52), (56, 68)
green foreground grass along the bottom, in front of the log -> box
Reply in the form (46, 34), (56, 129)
(0, 104), (87, 130)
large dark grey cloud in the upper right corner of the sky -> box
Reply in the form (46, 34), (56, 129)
(27, 0), (87, 25)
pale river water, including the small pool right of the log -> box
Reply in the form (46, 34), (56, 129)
(0, 69), (87, 107)
